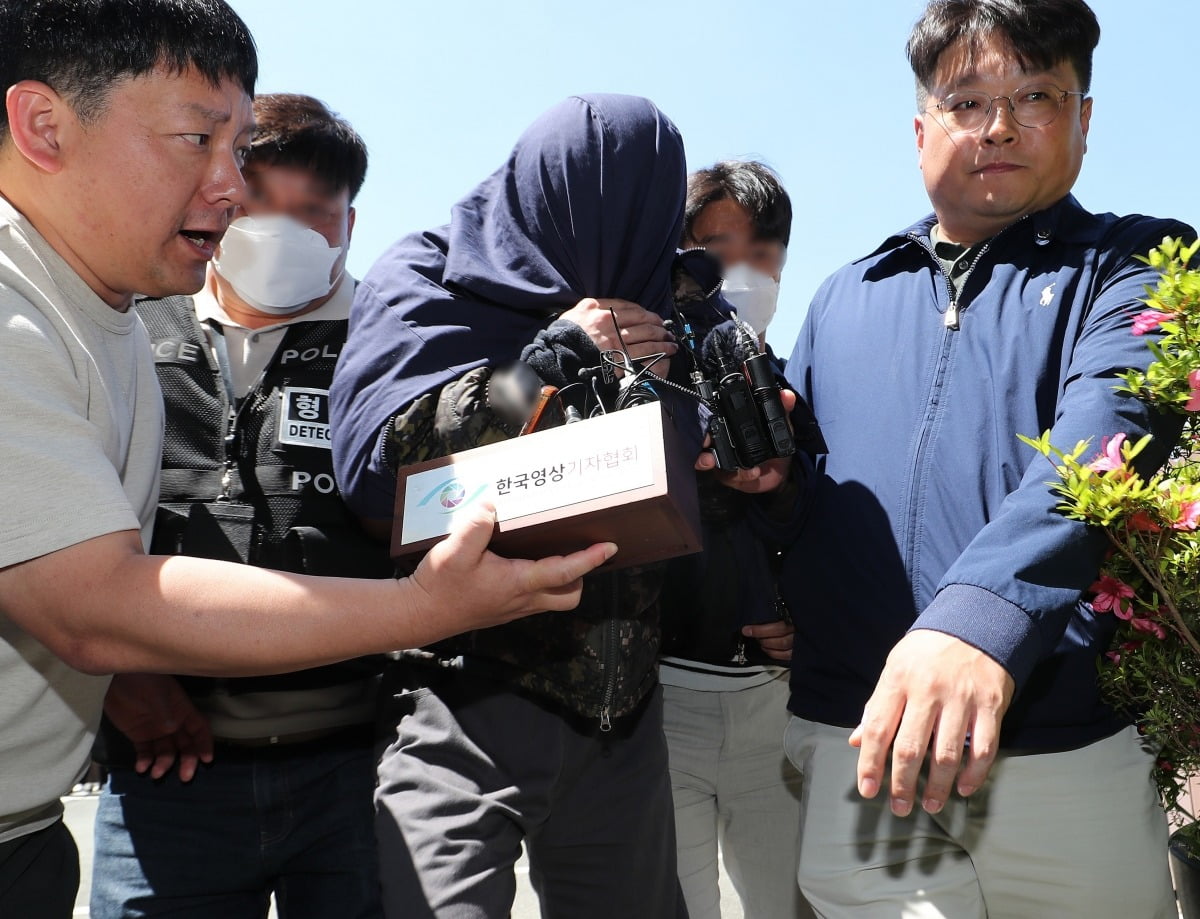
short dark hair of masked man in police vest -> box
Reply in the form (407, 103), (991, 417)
(246, 92), (367, 202)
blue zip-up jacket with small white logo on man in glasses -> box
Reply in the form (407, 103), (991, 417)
(781, 197), (1195, 750)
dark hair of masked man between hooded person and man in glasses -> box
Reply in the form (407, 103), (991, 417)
(683, 160), (792, 246)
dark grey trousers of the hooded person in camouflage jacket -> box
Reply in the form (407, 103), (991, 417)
(376, 668), (686, 919)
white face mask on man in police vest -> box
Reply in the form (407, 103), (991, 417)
(212, 214), (342, 316)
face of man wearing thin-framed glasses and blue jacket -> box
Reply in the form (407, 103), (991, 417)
(916, 36), (1092, 245)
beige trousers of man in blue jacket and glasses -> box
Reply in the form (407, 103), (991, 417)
(785, 717), (1176, 919)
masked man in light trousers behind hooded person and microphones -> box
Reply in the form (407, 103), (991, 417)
(659, 162), (812, 919)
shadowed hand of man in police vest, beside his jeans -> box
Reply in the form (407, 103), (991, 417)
(104, 673), (212, 782)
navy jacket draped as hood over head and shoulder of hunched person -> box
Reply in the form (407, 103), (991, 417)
(330, 95), (686, 518)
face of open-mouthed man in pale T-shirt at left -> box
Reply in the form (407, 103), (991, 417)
(54, 70), (253, 308)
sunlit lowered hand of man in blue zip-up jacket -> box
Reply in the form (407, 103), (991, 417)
(850, 629), (1015, 817)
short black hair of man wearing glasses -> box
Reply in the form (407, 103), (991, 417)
(906, 0), (1100, 108)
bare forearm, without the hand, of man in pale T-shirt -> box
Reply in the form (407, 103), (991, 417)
(4, 534), (434, 675)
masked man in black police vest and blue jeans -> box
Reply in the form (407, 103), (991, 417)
(91, 94), (389, 917)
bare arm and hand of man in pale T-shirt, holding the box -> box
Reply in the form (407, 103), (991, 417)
(0, 507), (616, 675)
